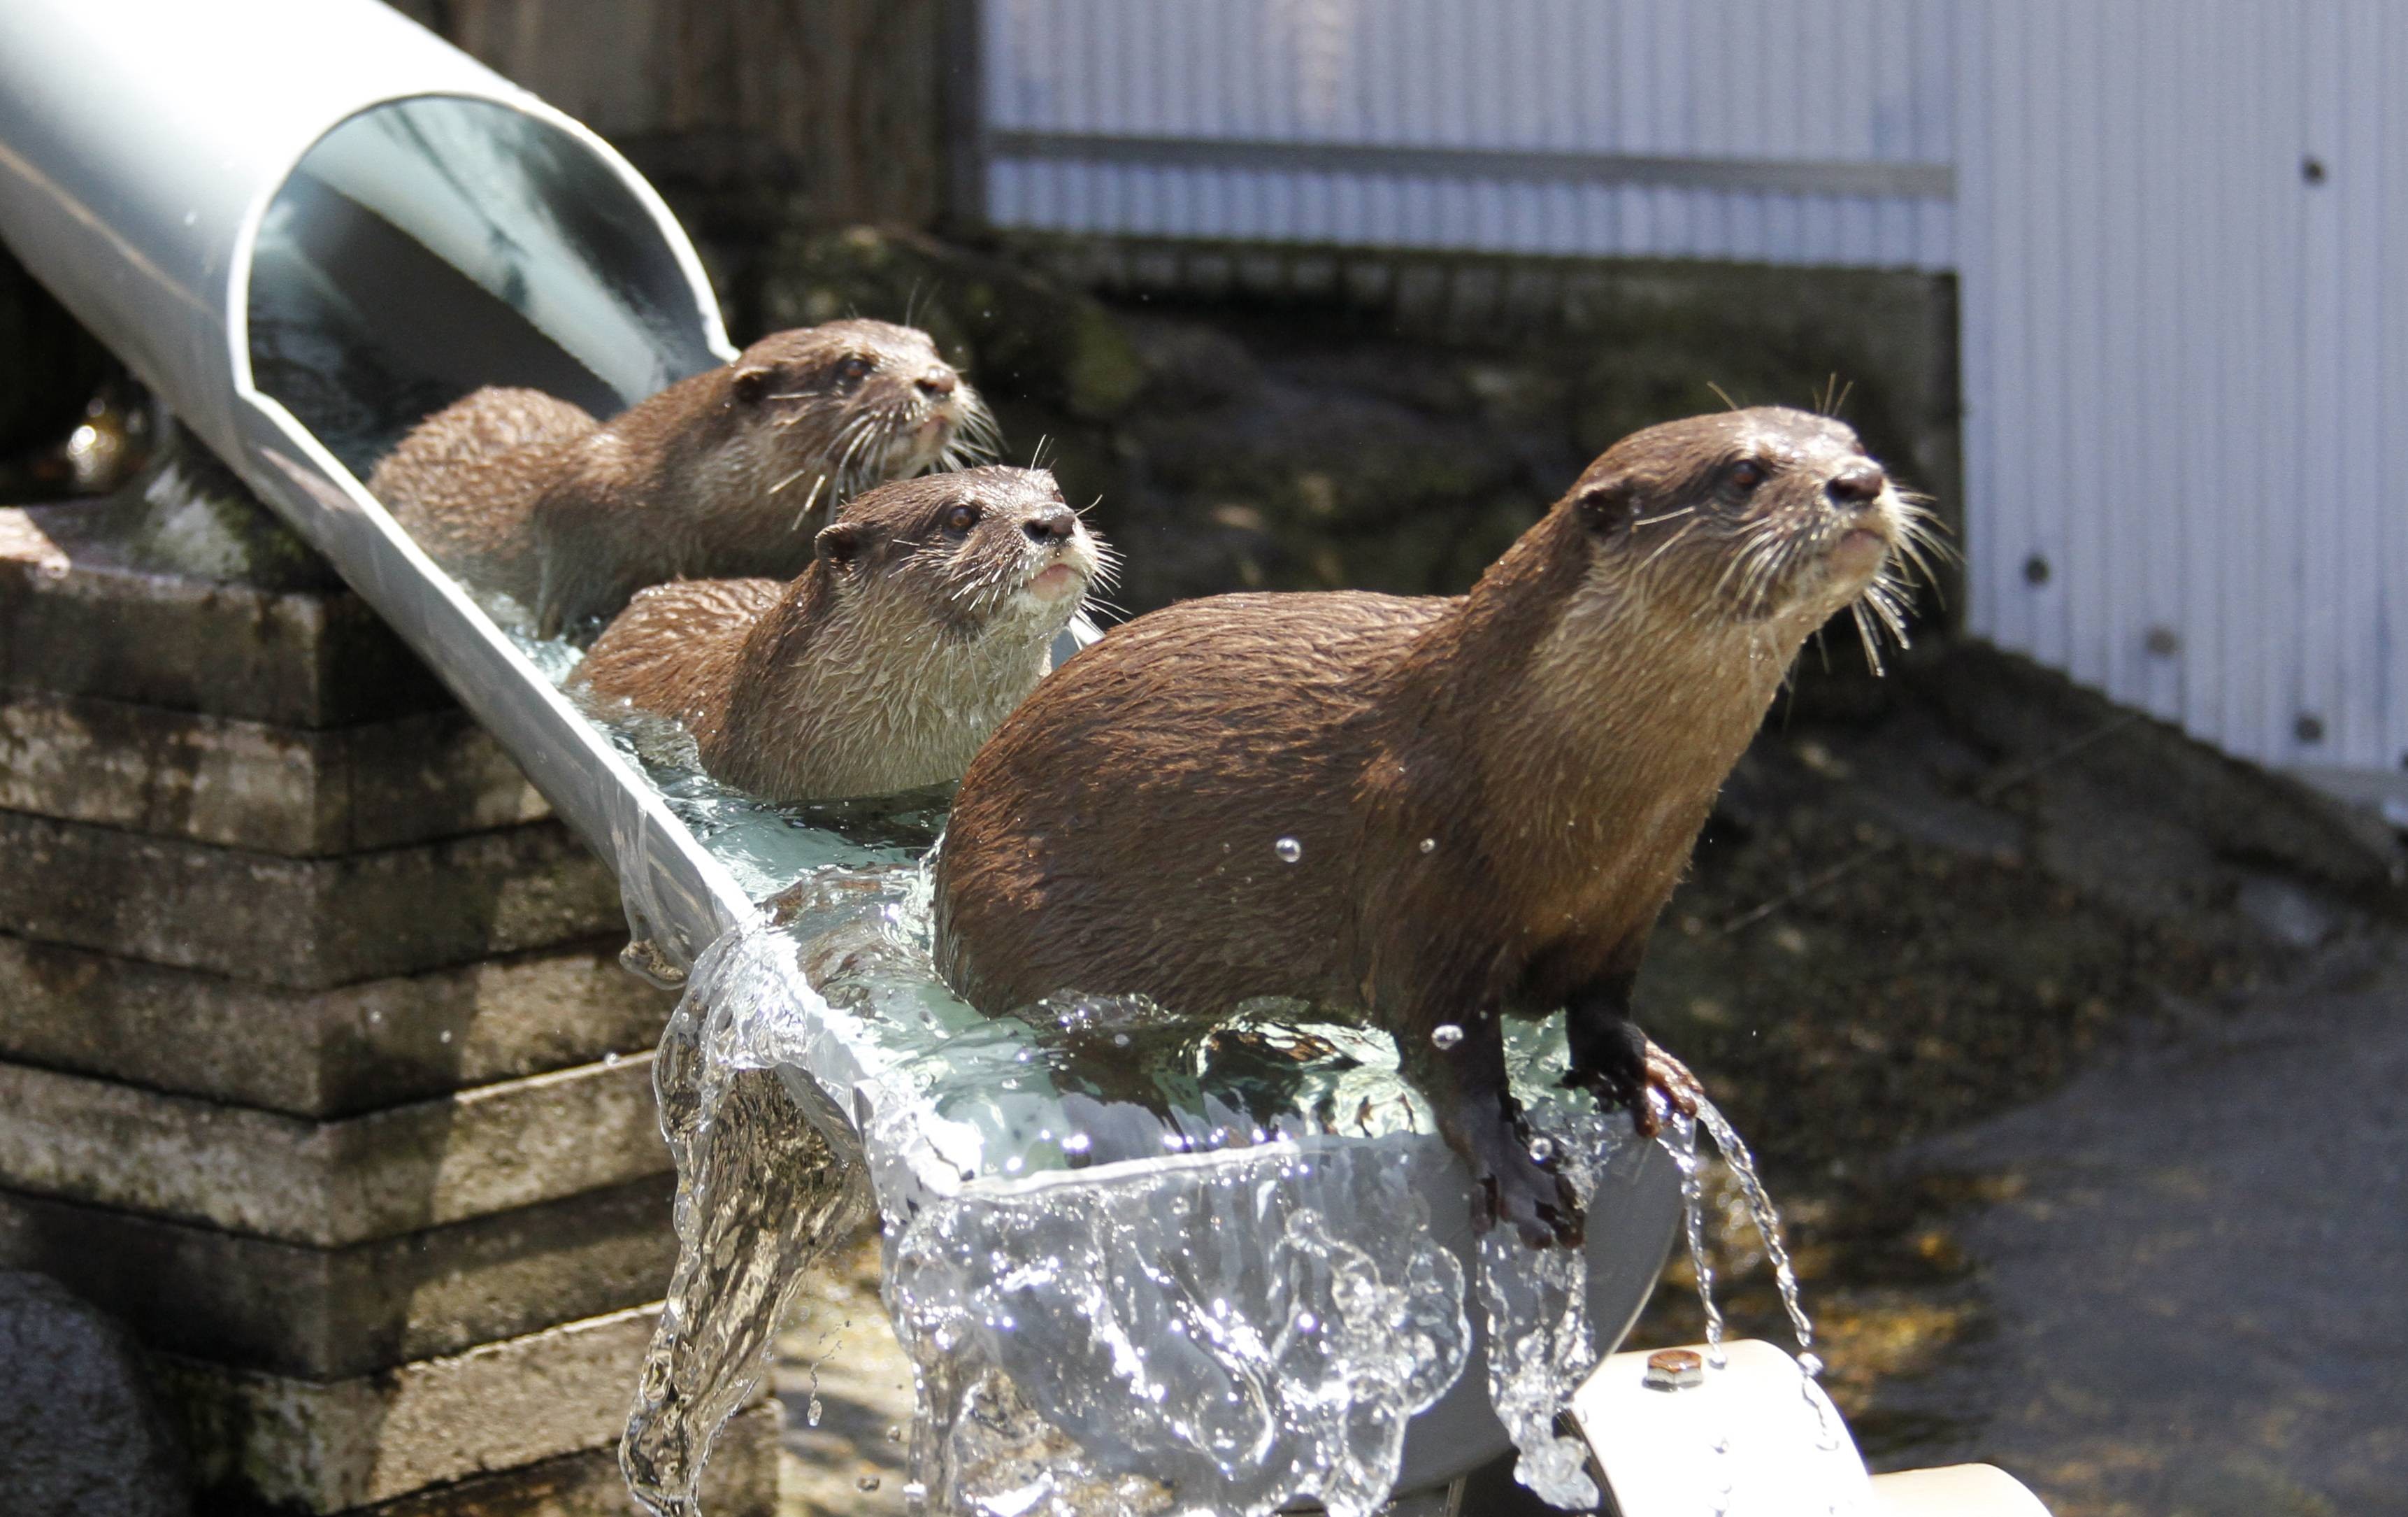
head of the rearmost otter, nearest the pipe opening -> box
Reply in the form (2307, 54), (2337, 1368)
(727, 320), (994, 508)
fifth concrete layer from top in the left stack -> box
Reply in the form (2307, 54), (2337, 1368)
(0, 1055), (669, 1247)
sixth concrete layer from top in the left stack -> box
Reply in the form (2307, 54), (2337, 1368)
(0, 1175), (677, 1380)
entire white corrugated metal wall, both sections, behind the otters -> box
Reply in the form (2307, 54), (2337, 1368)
(980, 0), (2408, 783)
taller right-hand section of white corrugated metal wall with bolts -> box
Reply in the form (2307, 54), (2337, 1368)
(1958, 0), (2408, 771)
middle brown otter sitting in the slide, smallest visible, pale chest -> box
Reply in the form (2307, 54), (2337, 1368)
(568, 467), (1110, 804)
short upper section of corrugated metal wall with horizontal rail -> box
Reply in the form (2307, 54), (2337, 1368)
(980, 0), (1956, 267)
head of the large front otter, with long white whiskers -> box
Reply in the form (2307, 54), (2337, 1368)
(1563, 407), (1924, 667)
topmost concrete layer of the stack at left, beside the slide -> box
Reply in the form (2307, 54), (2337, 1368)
(0, 504), (452, 727)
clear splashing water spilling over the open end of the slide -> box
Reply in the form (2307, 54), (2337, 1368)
(508, 646), (1804, 1517)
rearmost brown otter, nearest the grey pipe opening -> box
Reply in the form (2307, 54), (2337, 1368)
(368, 320), (994, 638)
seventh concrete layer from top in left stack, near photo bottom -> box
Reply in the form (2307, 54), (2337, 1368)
(157, 1305), (766, 1512)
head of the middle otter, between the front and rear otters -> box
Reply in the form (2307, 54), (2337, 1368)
(814, 464), (1112, 643)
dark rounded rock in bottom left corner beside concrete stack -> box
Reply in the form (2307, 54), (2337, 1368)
(0, 1269), (193, 1517)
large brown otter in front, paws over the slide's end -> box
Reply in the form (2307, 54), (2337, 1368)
(937, 409), (1914, 1245)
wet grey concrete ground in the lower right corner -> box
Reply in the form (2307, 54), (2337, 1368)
(1881, 951), (2408, 1517)
